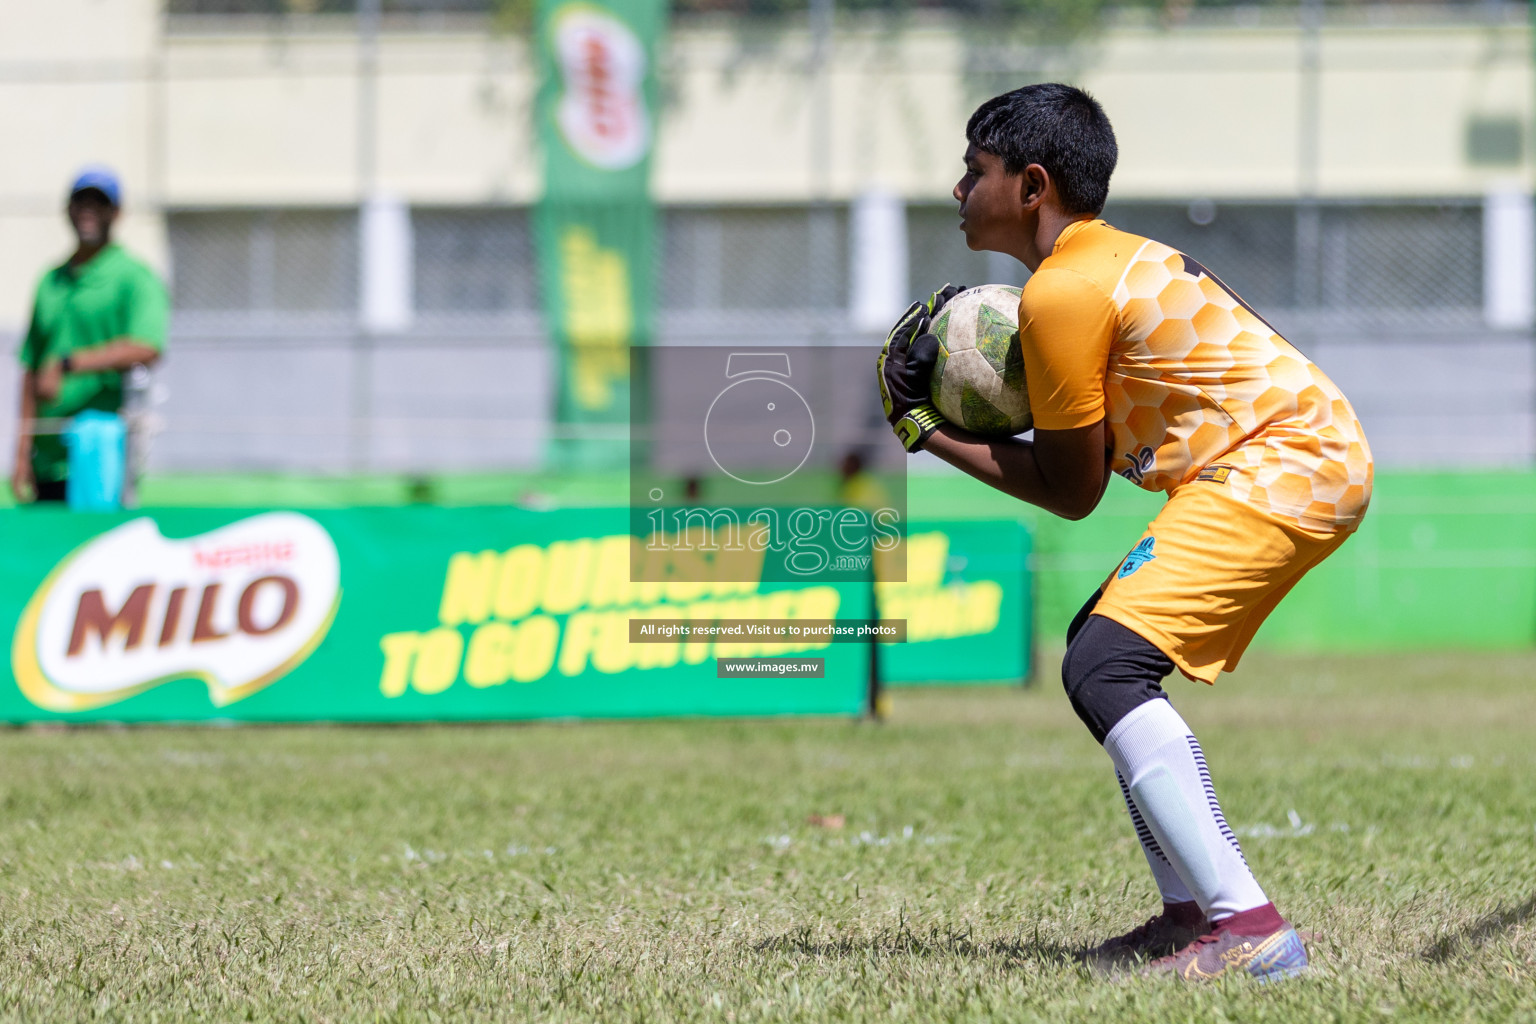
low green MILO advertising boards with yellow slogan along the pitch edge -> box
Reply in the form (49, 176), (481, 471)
(0, 507), (1028, 722)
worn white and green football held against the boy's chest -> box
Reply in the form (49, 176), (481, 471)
(932, 284), (1034, 436)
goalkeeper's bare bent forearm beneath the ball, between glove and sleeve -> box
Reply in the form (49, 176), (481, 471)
(923, 419), (1109, 519)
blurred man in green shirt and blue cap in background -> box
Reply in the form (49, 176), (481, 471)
(11, 167), (169, 502)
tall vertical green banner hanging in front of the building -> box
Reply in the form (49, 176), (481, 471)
(536, 0), (667, 467)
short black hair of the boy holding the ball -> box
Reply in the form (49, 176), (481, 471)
(965, 81), (1120, 213)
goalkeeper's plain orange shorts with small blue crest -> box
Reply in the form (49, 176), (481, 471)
(1094, 482), (1353, 683)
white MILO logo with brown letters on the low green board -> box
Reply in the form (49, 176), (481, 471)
(6, 511), (341, 711)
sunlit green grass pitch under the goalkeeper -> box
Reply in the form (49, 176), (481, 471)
(0, 656), (1536, 1024)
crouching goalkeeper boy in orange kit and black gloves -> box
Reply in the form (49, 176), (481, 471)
(879, 84), (1372, 978)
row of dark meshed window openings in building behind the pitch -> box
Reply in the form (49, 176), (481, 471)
(158, 200), (1484, 323)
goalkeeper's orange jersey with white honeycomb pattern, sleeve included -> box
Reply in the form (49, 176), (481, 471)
(1018, 221), (1372, 531)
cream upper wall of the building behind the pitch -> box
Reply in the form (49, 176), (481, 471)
(0, 0), (1536, 329)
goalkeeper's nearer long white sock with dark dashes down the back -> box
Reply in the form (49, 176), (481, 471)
(1104, 699), (1269, 921)
